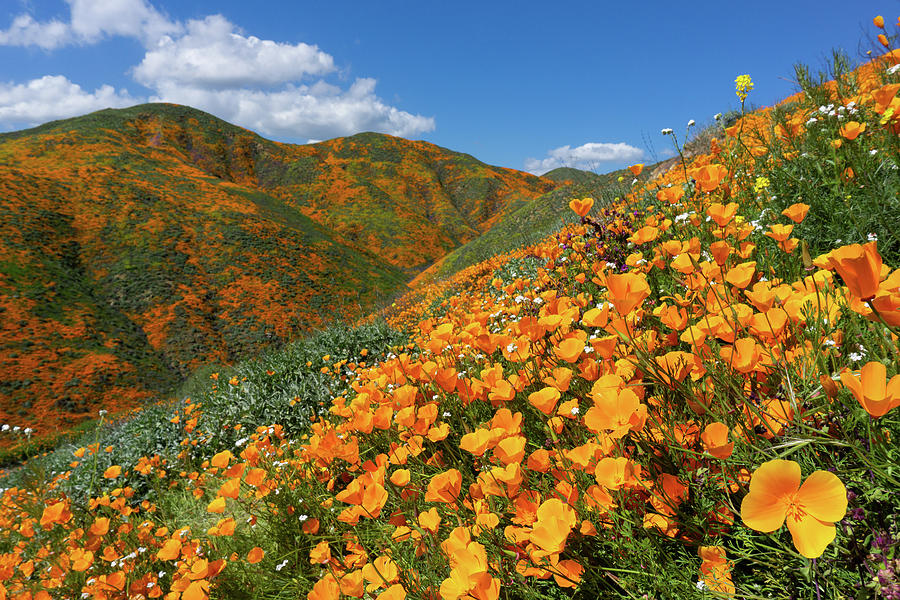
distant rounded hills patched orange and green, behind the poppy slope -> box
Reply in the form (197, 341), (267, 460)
(0, 104), (557, 434)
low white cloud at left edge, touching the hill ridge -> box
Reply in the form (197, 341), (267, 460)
(0, 75), (142, 125)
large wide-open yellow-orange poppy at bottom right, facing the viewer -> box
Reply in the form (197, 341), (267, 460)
(741, 459), (847, 558)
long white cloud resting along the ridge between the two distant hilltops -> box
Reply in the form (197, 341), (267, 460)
(152, 79), (434, 140)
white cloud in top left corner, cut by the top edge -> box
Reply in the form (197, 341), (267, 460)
(0, 0), (182, 50)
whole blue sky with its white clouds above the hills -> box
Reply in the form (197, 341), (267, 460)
(0, 0), (900, 172)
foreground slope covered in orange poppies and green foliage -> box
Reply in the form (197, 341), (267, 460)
(0, 17), (900, 600)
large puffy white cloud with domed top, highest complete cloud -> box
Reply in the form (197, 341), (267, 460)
(134, 15), (334, 89)
